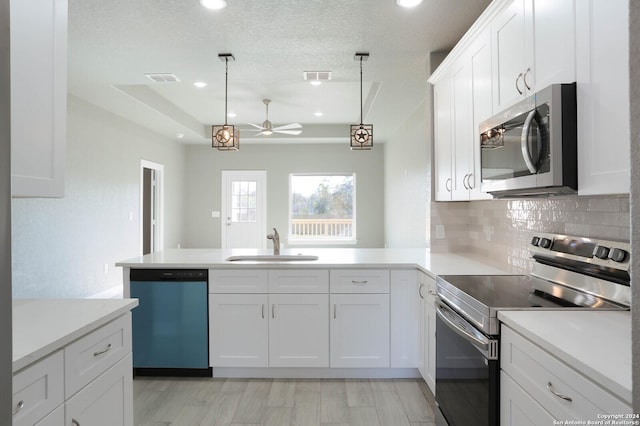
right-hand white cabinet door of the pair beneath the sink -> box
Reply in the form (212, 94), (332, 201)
(269, 294), (329, 367)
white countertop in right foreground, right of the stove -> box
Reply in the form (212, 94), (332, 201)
(498, 310), (631, 404)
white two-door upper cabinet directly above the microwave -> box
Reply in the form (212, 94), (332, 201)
(491, 0), (576, 112)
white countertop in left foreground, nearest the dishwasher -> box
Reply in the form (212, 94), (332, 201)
(13, 299), (138, 373)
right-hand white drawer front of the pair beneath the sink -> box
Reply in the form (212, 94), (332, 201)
(269, 269), (329, 293)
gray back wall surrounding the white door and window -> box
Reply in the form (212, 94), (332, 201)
(183, 144), (384, 248)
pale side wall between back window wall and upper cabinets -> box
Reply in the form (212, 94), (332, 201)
(384, 99), (431, 247)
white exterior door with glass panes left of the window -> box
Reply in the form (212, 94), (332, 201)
(221, 170), (267, 248)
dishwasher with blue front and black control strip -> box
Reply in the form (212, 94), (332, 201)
(129, 269), (212, 377)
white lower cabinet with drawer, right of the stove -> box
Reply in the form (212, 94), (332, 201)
(500, 325), (632, 426)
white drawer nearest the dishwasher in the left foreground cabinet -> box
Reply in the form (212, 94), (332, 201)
(64, 313), (131, 398)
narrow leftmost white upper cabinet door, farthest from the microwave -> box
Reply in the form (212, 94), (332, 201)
(433, 77), (453, 201)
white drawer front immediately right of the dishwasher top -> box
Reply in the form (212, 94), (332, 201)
(209, 269), (269, 293)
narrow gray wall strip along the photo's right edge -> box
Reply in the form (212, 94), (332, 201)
(629, 0), (640, 413)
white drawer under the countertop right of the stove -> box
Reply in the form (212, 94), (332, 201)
(500, 326), (631, 420)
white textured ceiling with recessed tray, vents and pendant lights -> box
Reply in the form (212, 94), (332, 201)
(69, 0), (489, 144)
